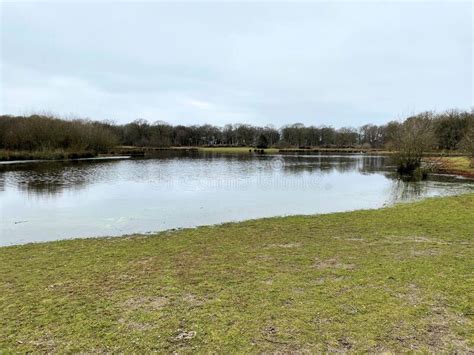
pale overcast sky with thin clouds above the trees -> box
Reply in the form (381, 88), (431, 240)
(0, 1), (474, 127)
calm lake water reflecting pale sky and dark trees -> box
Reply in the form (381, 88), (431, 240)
(0, 152), (474, 246)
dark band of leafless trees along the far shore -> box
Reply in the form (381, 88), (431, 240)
(0, 110), (474, 153)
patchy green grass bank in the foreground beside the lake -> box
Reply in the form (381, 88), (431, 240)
(0, 194), (474, 353)
